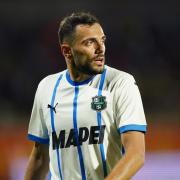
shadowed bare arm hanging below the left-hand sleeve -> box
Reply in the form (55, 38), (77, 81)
(24, 142), (49, 180)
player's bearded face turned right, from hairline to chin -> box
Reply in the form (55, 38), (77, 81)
(71, 23), (105, 75)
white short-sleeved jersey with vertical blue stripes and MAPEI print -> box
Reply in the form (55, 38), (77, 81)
(28, 66), (146, 180)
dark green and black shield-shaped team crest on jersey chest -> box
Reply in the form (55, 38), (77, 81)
(91, 96), (107, 111)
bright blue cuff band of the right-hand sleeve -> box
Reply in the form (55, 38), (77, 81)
(118, 124), (147, 133)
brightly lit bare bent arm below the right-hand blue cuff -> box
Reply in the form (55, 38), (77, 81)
(106, 131), (145, 180)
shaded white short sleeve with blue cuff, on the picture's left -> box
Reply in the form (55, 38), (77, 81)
(28, 82), (49, 144)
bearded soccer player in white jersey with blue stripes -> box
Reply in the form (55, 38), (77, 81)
(25, 12), (146, 180)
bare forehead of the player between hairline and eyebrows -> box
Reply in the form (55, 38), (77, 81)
(74, 23), (104, 40)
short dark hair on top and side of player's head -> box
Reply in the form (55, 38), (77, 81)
(58, 12), (99, 44)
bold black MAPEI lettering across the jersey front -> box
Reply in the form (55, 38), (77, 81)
(52, 125), (106, 150)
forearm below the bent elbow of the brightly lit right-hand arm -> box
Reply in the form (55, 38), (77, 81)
(106, 152), (144, 180)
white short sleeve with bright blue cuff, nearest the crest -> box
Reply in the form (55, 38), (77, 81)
(114, 75), (147, 133)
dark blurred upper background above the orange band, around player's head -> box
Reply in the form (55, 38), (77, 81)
(0, 0), (180, 119)
